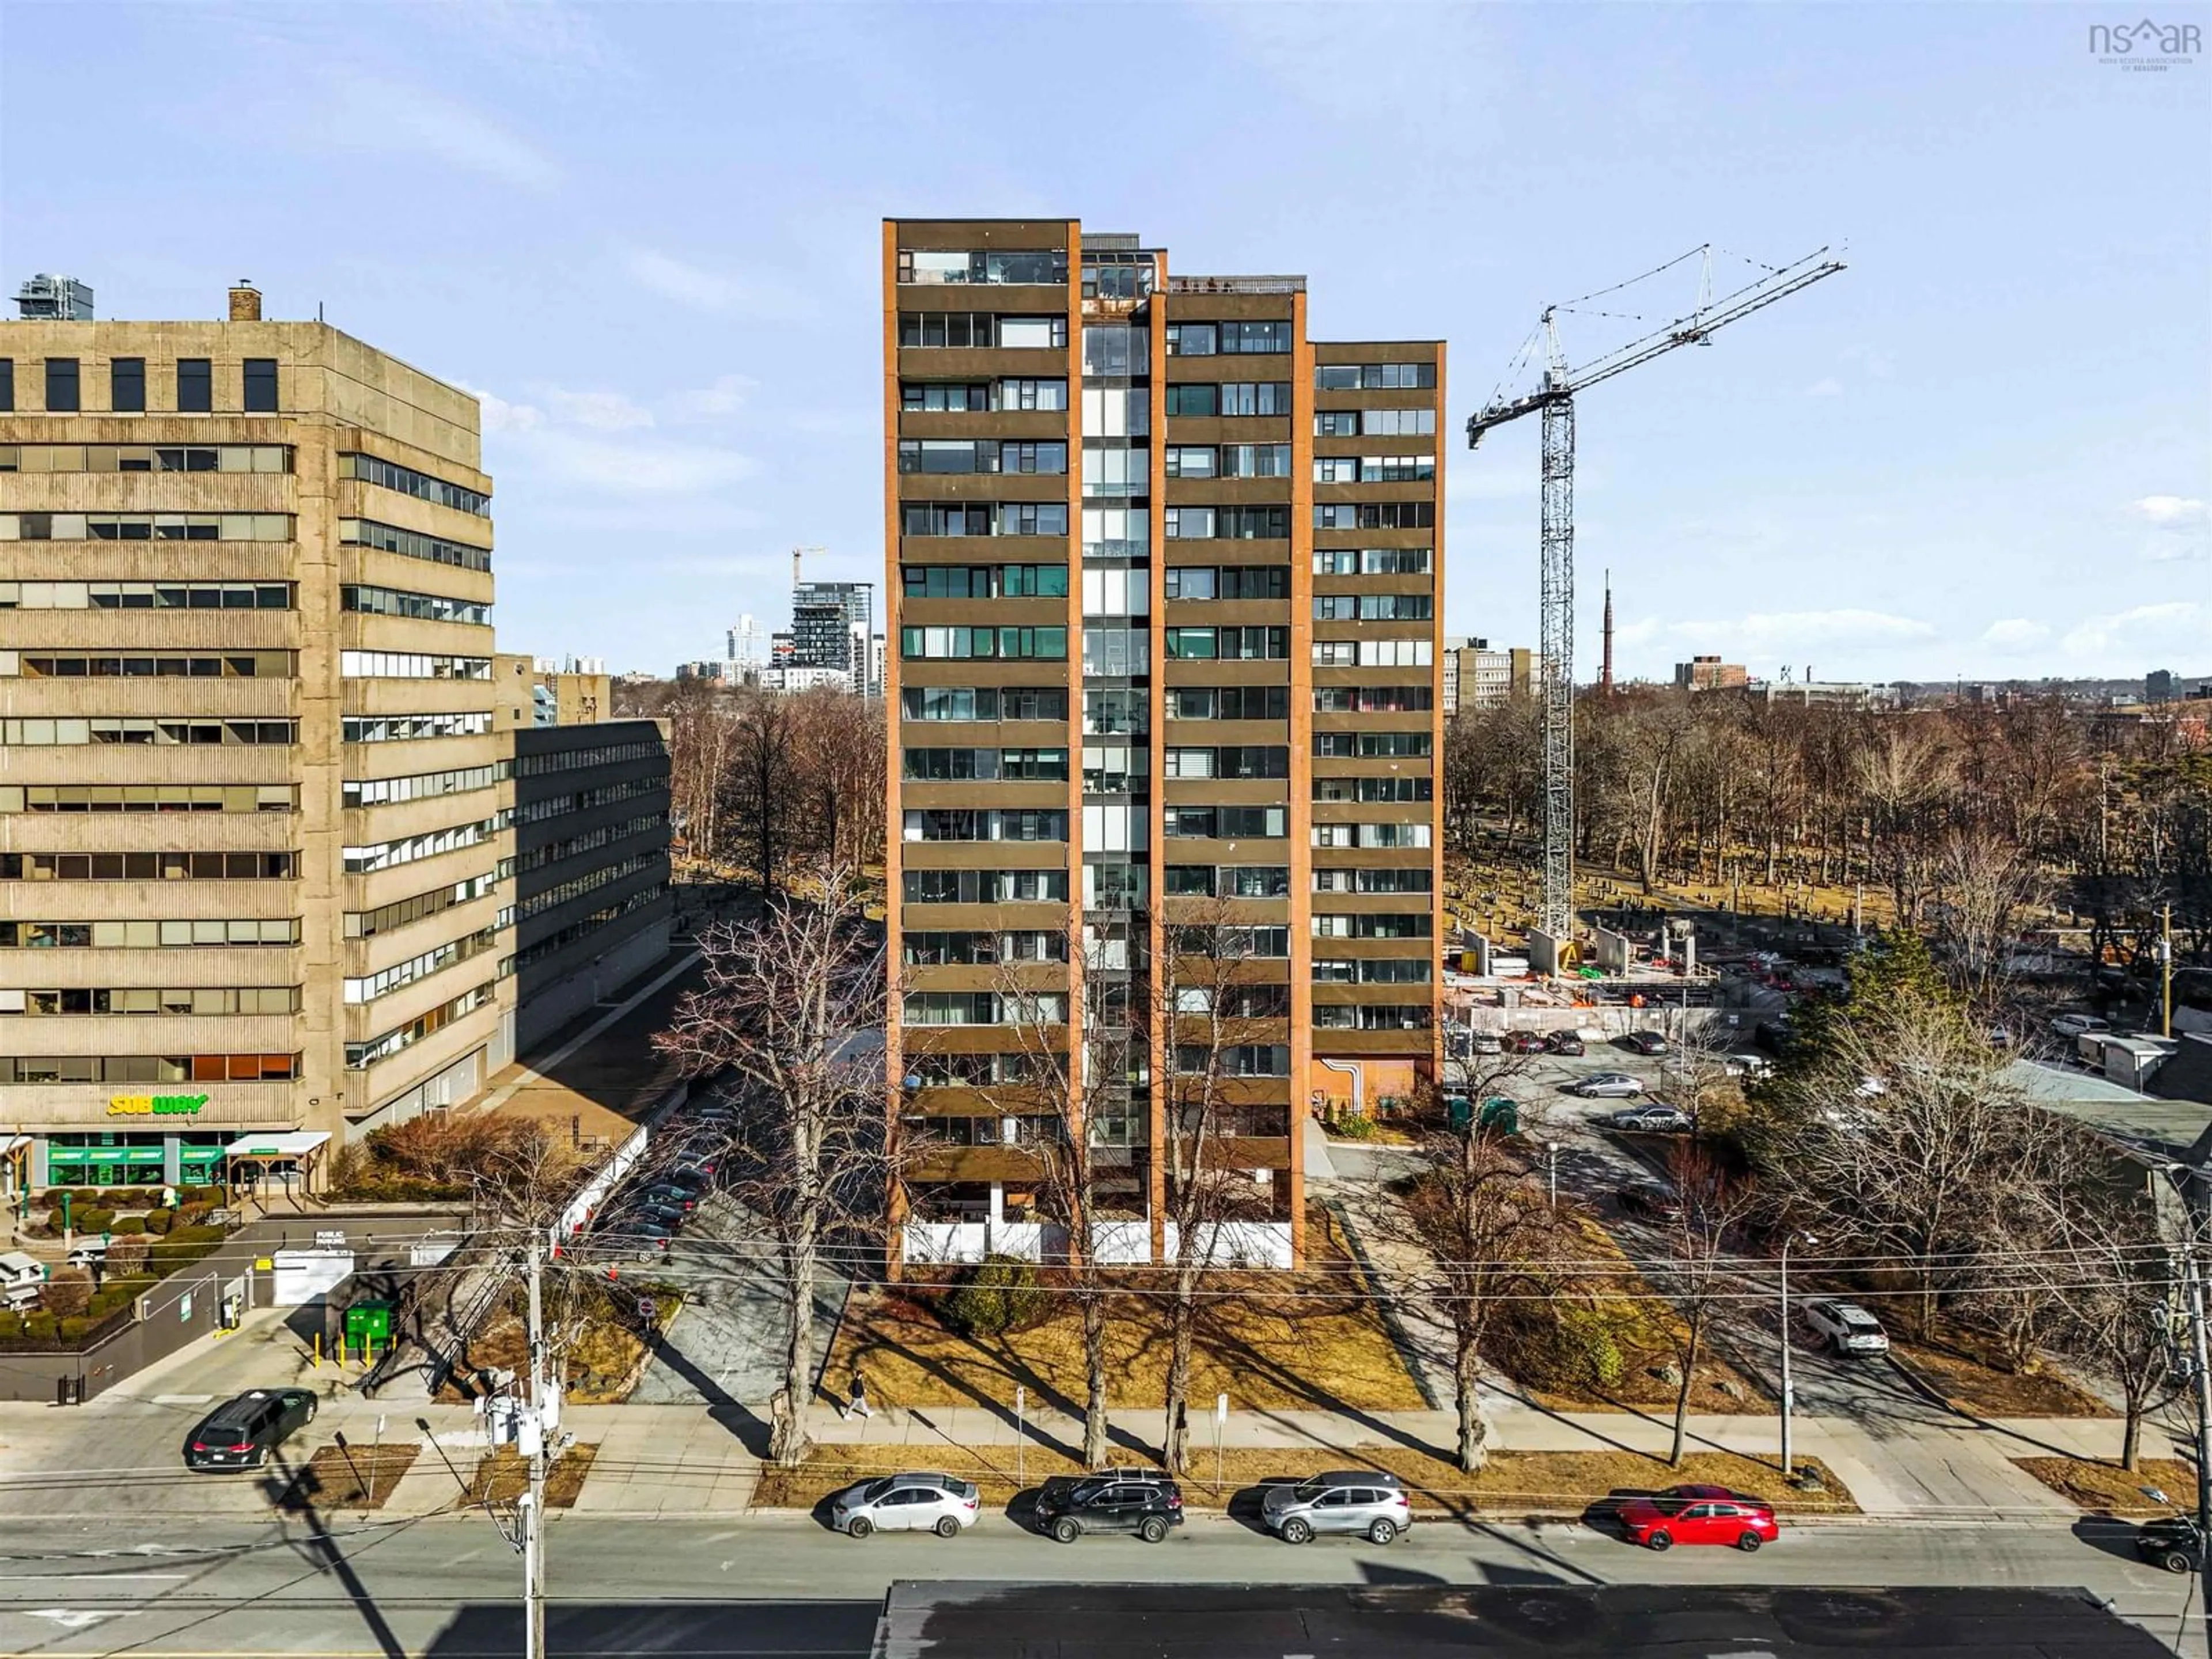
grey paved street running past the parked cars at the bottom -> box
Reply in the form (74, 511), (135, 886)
(0, 1515), (2205, 1659)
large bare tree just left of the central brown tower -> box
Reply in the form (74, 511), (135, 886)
(655, 865), (896, 1462)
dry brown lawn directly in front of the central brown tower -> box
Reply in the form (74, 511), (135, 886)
(823, 1208), (1425, 1411)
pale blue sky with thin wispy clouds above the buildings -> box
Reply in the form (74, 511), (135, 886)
(0, 0), (2212, 679)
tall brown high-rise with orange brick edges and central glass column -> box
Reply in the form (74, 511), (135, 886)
(882, 221), (1445, 1261)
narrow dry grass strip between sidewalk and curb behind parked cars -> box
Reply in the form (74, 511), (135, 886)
(752, 1446), (1858, 1515)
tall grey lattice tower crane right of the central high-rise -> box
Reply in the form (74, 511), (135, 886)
(1467, 243), (1843, 951)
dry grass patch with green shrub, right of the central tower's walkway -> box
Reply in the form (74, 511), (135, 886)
(1486, 1217), (1774, 1418)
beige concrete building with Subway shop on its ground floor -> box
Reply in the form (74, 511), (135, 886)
(0, 287), (668, 1185)
